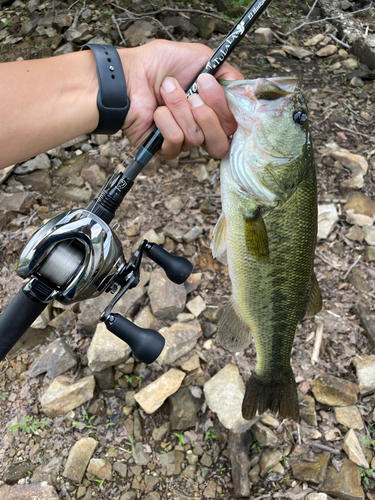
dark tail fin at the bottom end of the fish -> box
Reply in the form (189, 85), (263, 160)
(242, 373), (299, 420)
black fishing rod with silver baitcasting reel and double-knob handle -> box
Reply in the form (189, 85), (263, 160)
(0, 0), (272, 363)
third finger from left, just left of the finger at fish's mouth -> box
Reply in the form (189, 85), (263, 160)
(189, 94), (229, 158)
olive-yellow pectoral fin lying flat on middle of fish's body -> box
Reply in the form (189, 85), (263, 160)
(244, 210), (269, 262)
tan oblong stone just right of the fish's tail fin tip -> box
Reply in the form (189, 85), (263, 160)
(312, 374), (359, 406)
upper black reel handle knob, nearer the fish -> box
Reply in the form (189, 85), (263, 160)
(145, 243), (193, 285)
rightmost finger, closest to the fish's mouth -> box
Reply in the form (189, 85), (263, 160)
(198, 73), (237, 135)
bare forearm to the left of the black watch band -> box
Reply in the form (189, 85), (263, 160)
(0, 50), (99, 168)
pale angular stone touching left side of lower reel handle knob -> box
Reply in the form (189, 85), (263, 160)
(87, 323), (131, 372)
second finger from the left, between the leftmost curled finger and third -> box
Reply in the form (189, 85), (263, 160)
(160, 77), (204, 151)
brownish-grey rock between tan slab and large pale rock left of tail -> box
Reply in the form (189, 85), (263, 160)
(169, 387), (203, 431)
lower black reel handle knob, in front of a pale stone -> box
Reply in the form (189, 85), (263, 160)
(105, 313), (165, 363)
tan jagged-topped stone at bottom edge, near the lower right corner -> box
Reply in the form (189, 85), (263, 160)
(320, 459), (365, 500)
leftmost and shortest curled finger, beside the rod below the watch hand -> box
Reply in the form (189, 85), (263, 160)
(154, 106), (185, 160)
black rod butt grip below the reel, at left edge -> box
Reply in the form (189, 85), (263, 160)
(0, 288), (48, 361)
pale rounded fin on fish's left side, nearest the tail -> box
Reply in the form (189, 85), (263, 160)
(217, 295), (251, 352)
